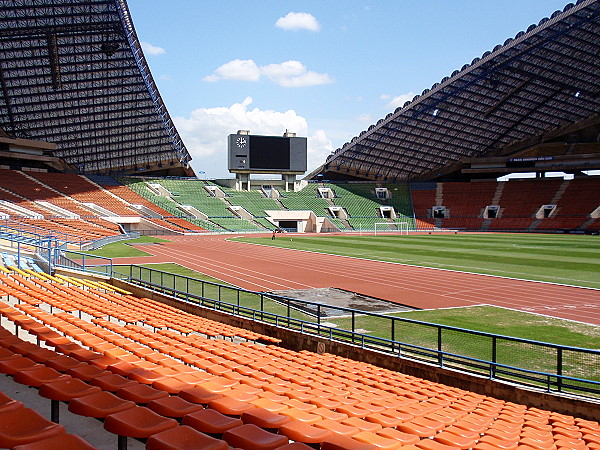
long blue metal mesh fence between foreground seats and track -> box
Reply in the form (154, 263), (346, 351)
(112, 266), (600, 398)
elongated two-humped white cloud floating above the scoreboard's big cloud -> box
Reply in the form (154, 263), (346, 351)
(203, 59), (333, 87)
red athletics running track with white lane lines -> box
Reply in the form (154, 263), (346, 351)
(114, 235), (600, 325)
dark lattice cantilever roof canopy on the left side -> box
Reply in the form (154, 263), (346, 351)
(0, 0), (191, 173)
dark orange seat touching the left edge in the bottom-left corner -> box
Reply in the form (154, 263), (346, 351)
(0, 408), (65, 448)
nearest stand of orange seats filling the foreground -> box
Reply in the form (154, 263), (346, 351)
(0, 273), (600, 450)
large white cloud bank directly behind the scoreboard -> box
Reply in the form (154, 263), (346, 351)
(173, 97), (333, 178)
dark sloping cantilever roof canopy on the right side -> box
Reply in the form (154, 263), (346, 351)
(309, 0), (600, 181)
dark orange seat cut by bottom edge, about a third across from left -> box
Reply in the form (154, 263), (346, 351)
(146, 425), (229, 450)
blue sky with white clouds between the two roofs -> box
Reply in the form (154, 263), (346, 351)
(128, 0), (566, 178)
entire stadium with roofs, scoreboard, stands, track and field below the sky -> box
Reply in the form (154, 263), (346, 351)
(0, 0), (600, 450)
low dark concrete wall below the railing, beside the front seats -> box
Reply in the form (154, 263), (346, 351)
(111, 279), (600, 420)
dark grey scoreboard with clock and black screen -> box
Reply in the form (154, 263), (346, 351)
(228, 134), (306, 173)
